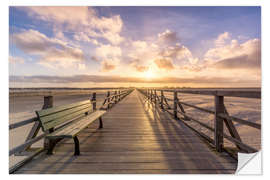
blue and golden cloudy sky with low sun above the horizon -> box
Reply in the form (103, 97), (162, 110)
(9, 6), (261, 87)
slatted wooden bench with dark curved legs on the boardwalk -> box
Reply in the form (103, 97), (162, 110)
(36, 100), (106, 155)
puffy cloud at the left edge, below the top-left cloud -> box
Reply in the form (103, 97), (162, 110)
(11, 29), (85, 68)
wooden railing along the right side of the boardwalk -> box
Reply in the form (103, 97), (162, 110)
(138, 88), (261, 155)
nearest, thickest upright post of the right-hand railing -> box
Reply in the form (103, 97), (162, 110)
(214, 95), (225, 152)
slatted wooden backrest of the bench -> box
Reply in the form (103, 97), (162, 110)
(36, 100), (92, 131)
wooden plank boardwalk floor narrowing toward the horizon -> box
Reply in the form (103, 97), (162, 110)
(15, 90), (237, 174)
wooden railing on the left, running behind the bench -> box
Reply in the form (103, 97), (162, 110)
(9, 89), (133, 173)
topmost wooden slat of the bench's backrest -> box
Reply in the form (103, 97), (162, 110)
(36, 100), (90, 117)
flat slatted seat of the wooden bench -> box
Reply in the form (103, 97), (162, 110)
(47, 110), (106, 138)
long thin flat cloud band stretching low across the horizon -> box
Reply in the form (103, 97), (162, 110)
(9, 75), (258, 84)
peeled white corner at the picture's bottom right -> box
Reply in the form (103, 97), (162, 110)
(235, 151), (262, 175)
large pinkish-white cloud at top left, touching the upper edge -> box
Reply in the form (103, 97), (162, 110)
(17, 6), (124, 45)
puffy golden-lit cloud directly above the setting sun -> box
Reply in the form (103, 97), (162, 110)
(128, 30), (196, 72)
